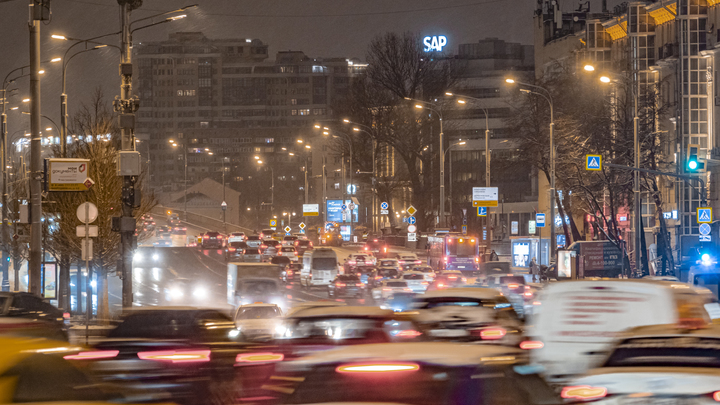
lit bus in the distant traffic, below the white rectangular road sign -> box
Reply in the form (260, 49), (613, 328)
(428, 233), (480, 271)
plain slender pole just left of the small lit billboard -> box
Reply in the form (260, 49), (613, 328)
(28, 0), (50, 295)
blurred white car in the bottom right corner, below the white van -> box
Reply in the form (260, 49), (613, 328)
(564, 324), (720, 405)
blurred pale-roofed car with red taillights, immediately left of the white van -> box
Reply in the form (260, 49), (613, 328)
(413, 287), (526, 347)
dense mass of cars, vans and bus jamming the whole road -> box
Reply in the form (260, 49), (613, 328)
(0, 223), (720, 405)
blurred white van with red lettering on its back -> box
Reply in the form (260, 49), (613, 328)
(525, 279), (716, 382)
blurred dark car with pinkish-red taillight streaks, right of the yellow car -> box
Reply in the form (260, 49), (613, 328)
(77, 307), (246, 405)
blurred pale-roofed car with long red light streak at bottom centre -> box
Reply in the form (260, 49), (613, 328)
(266, 342), (561, 405)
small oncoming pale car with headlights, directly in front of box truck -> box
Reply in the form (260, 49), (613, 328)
(234, 303), (283, 340)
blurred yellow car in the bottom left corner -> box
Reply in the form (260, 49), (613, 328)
(0, 336), (140, 405)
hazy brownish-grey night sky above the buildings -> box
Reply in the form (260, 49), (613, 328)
(0, 0), (617, 134)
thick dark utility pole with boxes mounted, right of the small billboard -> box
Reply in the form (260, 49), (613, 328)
(113, 0), (142, 308)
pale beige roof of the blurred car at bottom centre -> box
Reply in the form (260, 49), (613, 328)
(282, 342), (524, 371)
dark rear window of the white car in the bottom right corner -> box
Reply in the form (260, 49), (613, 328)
(605, 337), (720, 368)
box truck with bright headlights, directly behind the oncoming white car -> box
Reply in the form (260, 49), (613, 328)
(227, 262), (287, 310)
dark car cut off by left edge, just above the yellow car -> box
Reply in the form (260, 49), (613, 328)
(0, 286), (68, 341)
